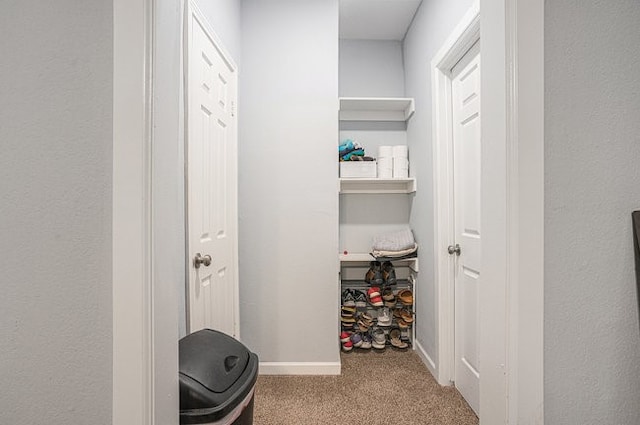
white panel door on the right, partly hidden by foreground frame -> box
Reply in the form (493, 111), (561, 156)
(451, 43), (482, 414)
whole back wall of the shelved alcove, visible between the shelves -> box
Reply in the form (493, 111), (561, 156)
(339, 39), (410, 258)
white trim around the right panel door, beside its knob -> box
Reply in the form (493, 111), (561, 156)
(431, 3), (480, 385)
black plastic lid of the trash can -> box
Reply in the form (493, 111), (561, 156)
(180, 329), (249, 393)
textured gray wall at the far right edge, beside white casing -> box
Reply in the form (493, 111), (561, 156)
(544, 0), (640, 425)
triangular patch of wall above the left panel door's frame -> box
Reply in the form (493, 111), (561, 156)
(196, 0), (242, 68)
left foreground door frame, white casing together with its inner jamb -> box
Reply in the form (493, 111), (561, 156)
(112, 0), (182, 425)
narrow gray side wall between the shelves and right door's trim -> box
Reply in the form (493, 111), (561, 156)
(404, 0), (473, 367)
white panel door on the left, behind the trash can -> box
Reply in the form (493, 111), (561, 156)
(187, 9), (238, 336)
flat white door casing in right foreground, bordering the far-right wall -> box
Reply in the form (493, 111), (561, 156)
(505, 0), (544, 424)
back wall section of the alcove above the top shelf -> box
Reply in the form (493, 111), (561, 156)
(339, 40), (404, 97)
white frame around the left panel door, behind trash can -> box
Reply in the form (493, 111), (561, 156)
(182, 0), (240, 339)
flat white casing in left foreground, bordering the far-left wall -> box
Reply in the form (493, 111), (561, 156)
(112, 0), (155, 425)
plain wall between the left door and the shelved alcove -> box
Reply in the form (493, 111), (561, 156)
(239, 0), (340, 363)
